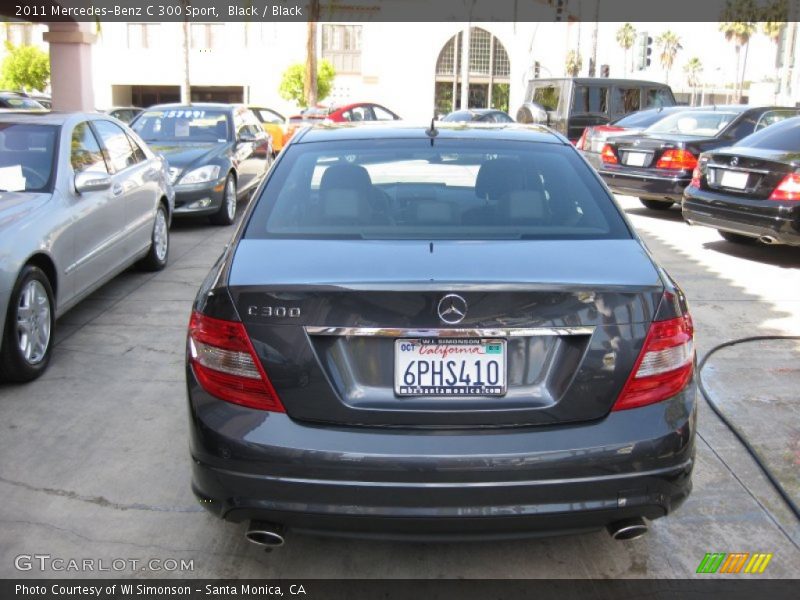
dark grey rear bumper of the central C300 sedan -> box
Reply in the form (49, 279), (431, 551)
(188, 372), (696, 540)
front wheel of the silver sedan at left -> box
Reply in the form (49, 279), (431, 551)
(0, 265), (55, 382)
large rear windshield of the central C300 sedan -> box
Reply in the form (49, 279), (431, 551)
(246, 139), (630, 240)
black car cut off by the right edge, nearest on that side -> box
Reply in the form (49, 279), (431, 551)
(682, 117), (800, 246)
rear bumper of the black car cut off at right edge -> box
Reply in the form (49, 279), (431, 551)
(682, 189), (800, 246)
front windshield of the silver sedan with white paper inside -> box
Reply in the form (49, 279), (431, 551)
(0, 123), (58, 193)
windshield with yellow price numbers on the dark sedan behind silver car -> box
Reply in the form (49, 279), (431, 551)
(131, 106), (228, 142)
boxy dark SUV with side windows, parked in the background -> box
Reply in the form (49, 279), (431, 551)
(517, 77), (676, 143)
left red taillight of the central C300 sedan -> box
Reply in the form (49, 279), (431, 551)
(189, 312), (284, 412)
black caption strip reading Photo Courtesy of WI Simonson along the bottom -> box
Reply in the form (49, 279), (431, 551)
(0, 576), (797, 600)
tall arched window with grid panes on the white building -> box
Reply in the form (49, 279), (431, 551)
(435, 27), (511, 114)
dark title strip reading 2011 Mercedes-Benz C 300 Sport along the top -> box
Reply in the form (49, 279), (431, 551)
(2, 0), (800, 23)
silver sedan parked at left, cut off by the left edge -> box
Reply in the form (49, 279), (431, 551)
(0, 113), (174, 381)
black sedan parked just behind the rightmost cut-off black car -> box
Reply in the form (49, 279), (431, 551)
(599, 105), (800, 210)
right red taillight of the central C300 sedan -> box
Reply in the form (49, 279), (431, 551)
(612, 314), (694, 410)
